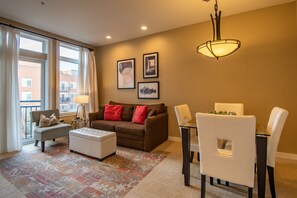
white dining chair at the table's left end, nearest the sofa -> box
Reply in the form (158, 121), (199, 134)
(174, 104), (199, 162)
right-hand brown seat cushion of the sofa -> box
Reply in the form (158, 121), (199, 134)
(115, 122), (144, 137)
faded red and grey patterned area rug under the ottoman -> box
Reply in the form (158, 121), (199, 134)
(0, 143), (166, 198)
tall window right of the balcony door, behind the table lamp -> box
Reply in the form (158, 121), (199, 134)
(59, 43), (80, 113)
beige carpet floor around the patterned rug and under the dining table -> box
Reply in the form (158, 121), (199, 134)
(0, 141), (297, 198)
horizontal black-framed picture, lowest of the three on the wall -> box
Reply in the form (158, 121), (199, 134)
(137, 81), (160, 99)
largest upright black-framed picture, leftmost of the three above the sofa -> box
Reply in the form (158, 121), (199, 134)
(117, 58), (135, 89)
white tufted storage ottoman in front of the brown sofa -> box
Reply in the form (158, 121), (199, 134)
(69, 128), (117, 160)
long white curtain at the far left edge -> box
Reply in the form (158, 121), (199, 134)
(0, 25), (22, 153)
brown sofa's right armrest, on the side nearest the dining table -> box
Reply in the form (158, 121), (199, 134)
(144, 113), (168, 151)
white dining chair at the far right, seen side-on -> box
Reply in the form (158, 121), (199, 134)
(266, 107), (289, 197)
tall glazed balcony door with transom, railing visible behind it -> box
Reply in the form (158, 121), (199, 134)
(18, 32), (48, 144)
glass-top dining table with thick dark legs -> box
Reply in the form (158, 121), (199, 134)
(179, 120), (270, 198)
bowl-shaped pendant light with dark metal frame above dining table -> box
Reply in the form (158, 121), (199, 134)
(197, 0), (241, 59)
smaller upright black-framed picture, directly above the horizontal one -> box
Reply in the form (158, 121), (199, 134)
(143, 52), (159, 78)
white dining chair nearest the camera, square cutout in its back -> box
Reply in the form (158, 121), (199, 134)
(196, 113), (256, 198)
